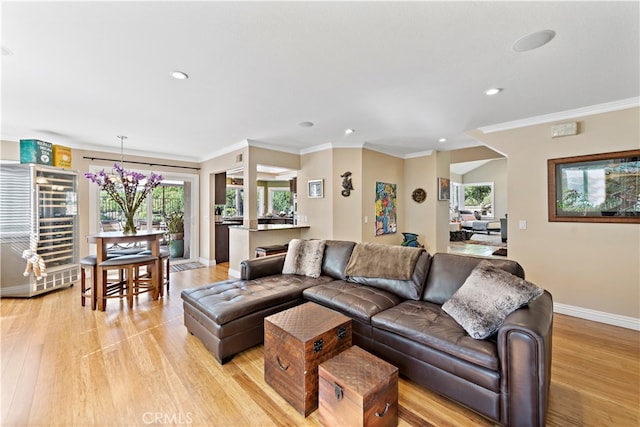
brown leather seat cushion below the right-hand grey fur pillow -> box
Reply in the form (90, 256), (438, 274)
(371, 301), (500, 371)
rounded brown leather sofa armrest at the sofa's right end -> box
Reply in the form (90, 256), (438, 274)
(498, 291), (553, 426)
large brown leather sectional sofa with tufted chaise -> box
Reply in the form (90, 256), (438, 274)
(182, 241), (553, 426)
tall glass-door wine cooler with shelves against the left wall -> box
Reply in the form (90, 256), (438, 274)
(0, 164), (80, 297)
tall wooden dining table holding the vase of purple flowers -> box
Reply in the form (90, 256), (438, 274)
(87, 230), (165, 311)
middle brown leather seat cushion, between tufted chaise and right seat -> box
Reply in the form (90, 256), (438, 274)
(302, 280), (402, 324)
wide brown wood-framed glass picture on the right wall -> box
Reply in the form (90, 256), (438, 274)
(547, 150), (640, 224)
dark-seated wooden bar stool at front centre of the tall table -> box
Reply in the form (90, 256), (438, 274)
(98, 255), (160, 307)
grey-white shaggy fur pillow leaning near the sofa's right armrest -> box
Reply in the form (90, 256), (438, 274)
(442, 261), (544, 339)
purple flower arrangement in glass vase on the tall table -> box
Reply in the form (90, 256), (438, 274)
(84, 163), (163, 233)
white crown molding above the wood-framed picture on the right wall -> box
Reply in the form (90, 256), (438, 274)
(478, 97), (640, 134)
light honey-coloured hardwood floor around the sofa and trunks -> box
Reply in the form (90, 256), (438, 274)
(0, 264), (640, 427)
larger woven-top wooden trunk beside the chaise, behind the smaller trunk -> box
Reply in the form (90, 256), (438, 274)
(264, 302), (351, 417)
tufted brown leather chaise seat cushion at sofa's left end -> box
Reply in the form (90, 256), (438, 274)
(181, 274), (333, 325)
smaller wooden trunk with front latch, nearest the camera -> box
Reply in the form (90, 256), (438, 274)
(318, 346), (398, 426)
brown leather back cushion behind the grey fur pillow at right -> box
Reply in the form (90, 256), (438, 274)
(422, 253), (524, 305)
